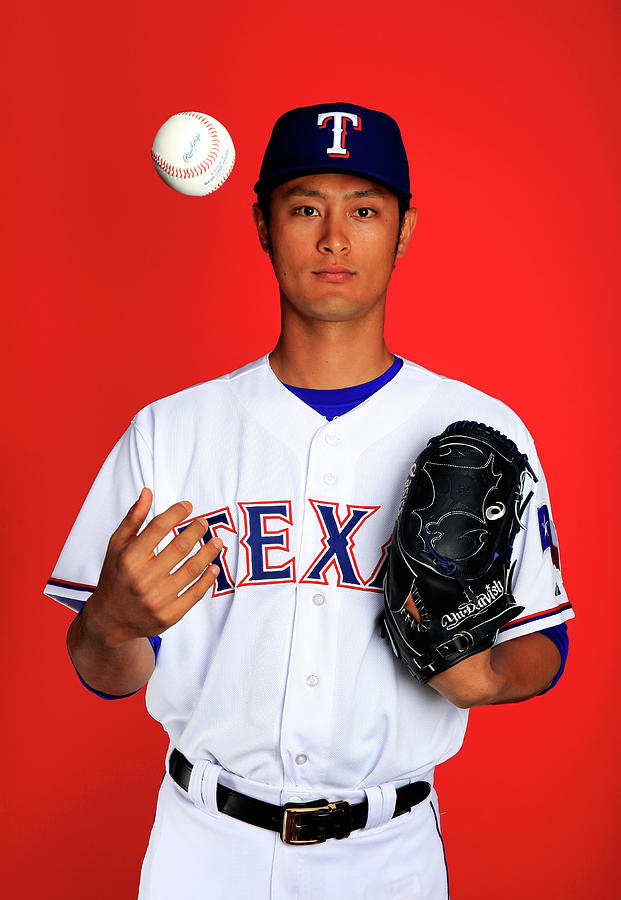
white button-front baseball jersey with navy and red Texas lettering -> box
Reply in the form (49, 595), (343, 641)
(46, 356), (573, 796)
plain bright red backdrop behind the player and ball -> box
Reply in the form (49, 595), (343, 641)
(0, 0), (621, 900)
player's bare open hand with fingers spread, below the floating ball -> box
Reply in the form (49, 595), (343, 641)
(81, 488), (222, 647)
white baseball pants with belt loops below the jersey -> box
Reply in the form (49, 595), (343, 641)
(138, 761), (448, 900)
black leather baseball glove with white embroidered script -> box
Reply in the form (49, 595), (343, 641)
(384, 422), (537, 684)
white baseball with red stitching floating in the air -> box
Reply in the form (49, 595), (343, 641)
(151, 112), (235, 197)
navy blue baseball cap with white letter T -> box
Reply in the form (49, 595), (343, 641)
(254, 102), (412, 201)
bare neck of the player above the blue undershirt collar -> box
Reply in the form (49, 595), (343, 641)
(270, 298), (394, 390)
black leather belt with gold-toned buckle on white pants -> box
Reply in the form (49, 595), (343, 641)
(168, 749), (431, 844)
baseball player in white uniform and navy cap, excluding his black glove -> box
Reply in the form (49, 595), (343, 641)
(46, 102), (573, 900)
